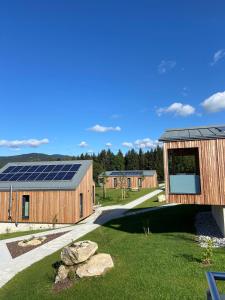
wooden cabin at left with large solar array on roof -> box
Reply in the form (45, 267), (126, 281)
(0, 160), (95, 232)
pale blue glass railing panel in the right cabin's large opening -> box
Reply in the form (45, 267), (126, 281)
(169, 174), (201, 194)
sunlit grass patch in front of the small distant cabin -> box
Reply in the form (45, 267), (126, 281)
(95, 187), (155, 206)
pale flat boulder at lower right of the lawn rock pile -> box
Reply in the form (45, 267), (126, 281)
(76, 253), (114, 278)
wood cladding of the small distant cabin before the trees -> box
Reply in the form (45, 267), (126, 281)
(106, 174), (158, 188)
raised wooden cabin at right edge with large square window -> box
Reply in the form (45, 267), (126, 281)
(160, 125), (225, 234)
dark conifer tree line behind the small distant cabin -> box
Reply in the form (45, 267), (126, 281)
(74, 146), (164, 183)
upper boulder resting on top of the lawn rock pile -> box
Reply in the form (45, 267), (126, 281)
(61, 241), (98, 266)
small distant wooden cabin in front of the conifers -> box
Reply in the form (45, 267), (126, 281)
(99, 170), (158, 189)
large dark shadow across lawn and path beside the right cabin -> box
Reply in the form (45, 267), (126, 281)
(95, 205), (209, 234)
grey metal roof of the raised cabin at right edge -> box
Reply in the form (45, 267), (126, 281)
(159, 125), (225, 142)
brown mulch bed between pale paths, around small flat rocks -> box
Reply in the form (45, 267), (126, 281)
(6, 231), (69, 258)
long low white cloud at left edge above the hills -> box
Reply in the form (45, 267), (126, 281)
(0, 138), (49, 150)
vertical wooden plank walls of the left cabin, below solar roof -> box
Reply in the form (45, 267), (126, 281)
(0, 166), (94, 224)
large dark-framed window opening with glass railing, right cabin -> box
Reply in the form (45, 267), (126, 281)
(168, 148), (201, 194)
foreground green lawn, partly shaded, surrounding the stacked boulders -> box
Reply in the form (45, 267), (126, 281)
(0, 205), (225, 300)
